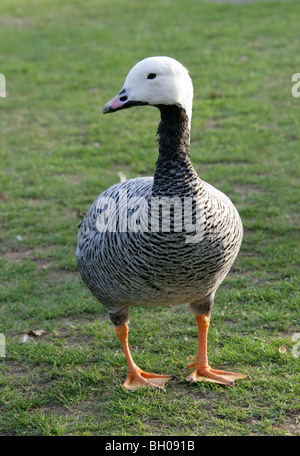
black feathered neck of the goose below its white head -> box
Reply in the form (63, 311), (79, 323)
(152, 106), (198, 196)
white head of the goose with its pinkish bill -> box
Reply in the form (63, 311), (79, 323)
(103, 57), (193, 128)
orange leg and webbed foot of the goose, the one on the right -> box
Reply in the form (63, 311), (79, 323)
(186, 315), (247, 385)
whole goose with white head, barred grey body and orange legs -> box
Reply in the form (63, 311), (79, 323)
(76, 56), (246, 391)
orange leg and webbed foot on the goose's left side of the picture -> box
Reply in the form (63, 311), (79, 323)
(115, 323), (173, 391)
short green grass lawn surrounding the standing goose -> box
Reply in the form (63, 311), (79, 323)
(0, 0), (300, 436)
